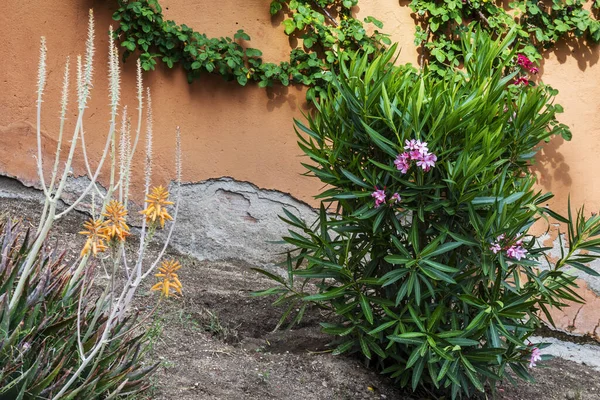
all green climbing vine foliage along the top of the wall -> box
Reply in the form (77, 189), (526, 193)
(113, 0), (600, 93)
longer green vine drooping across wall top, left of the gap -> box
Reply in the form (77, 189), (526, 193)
(113, 0), (390, 98)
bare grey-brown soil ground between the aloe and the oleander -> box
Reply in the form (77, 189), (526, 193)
(0, 199), (600, 400)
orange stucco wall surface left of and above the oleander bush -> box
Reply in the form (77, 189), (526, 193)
(0, 0), (416, 202)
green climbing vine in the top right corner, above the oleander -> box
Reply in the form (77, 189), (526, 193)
(410, 0), (600, 75)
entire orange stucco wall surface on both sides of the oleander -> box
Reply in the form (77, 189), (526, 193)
(0, 0), (600, 334)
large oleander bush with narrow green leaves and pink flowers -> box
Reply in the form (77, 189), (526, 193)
(257, 29), (600, 398)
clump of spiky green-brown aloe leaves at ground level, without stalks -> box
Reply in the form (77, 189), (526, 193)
(0, 217), (156, 400)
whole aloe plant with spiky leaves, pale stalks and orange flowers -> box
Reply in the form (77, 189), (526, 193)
(0, 10), (182, 400)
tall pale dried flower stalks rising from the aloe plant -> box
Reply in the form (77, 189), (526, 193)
(20, 11), (181, 400)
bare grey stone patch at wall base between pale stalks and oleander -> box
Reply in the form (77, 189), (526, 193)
(172, 178), (316, 266)
